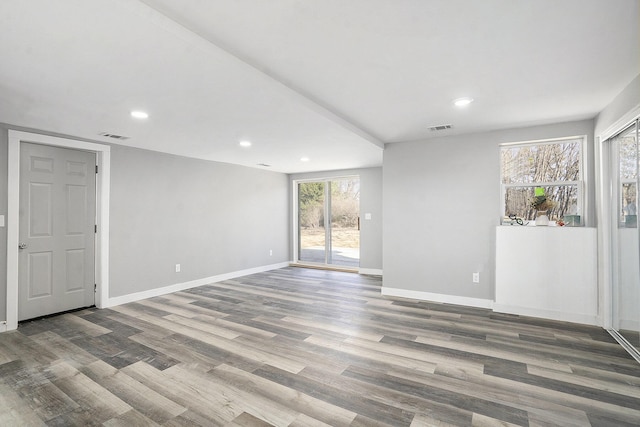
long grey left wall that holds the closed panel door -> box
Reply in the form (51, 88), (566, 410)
(0, 125), (290, 321)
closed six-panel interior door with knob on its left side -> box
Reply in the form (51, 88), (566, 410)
(18, 143), (96, 320)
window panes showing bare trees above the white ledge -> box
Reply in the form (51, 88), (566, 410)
(500, 137), (585, 221)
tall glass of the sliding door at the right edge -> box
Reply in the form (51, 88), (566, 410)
(611, 123), (640, 351)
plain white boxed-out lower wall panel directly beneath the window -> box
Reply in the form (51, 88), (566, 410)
(493, 226), (602, 325)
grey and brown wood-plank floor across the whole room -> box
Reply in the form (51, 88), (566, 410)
(0, 267), (640, 427)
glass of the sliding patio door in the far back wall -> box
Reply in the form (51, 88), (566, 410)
(298, 177), (360, 268)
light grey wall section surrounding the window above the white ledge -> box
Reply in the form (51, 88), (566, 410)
(383, 120), (595, 306)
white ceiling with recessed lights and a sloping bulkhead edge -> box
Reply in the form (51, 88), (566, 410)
(0, 0), (640, 173)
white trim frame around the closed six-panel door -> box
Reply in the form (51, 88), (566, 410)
(6, 130), (111, 330)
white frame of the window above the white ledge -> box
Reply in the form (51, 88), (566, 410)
(498, 135), (587, 226)
